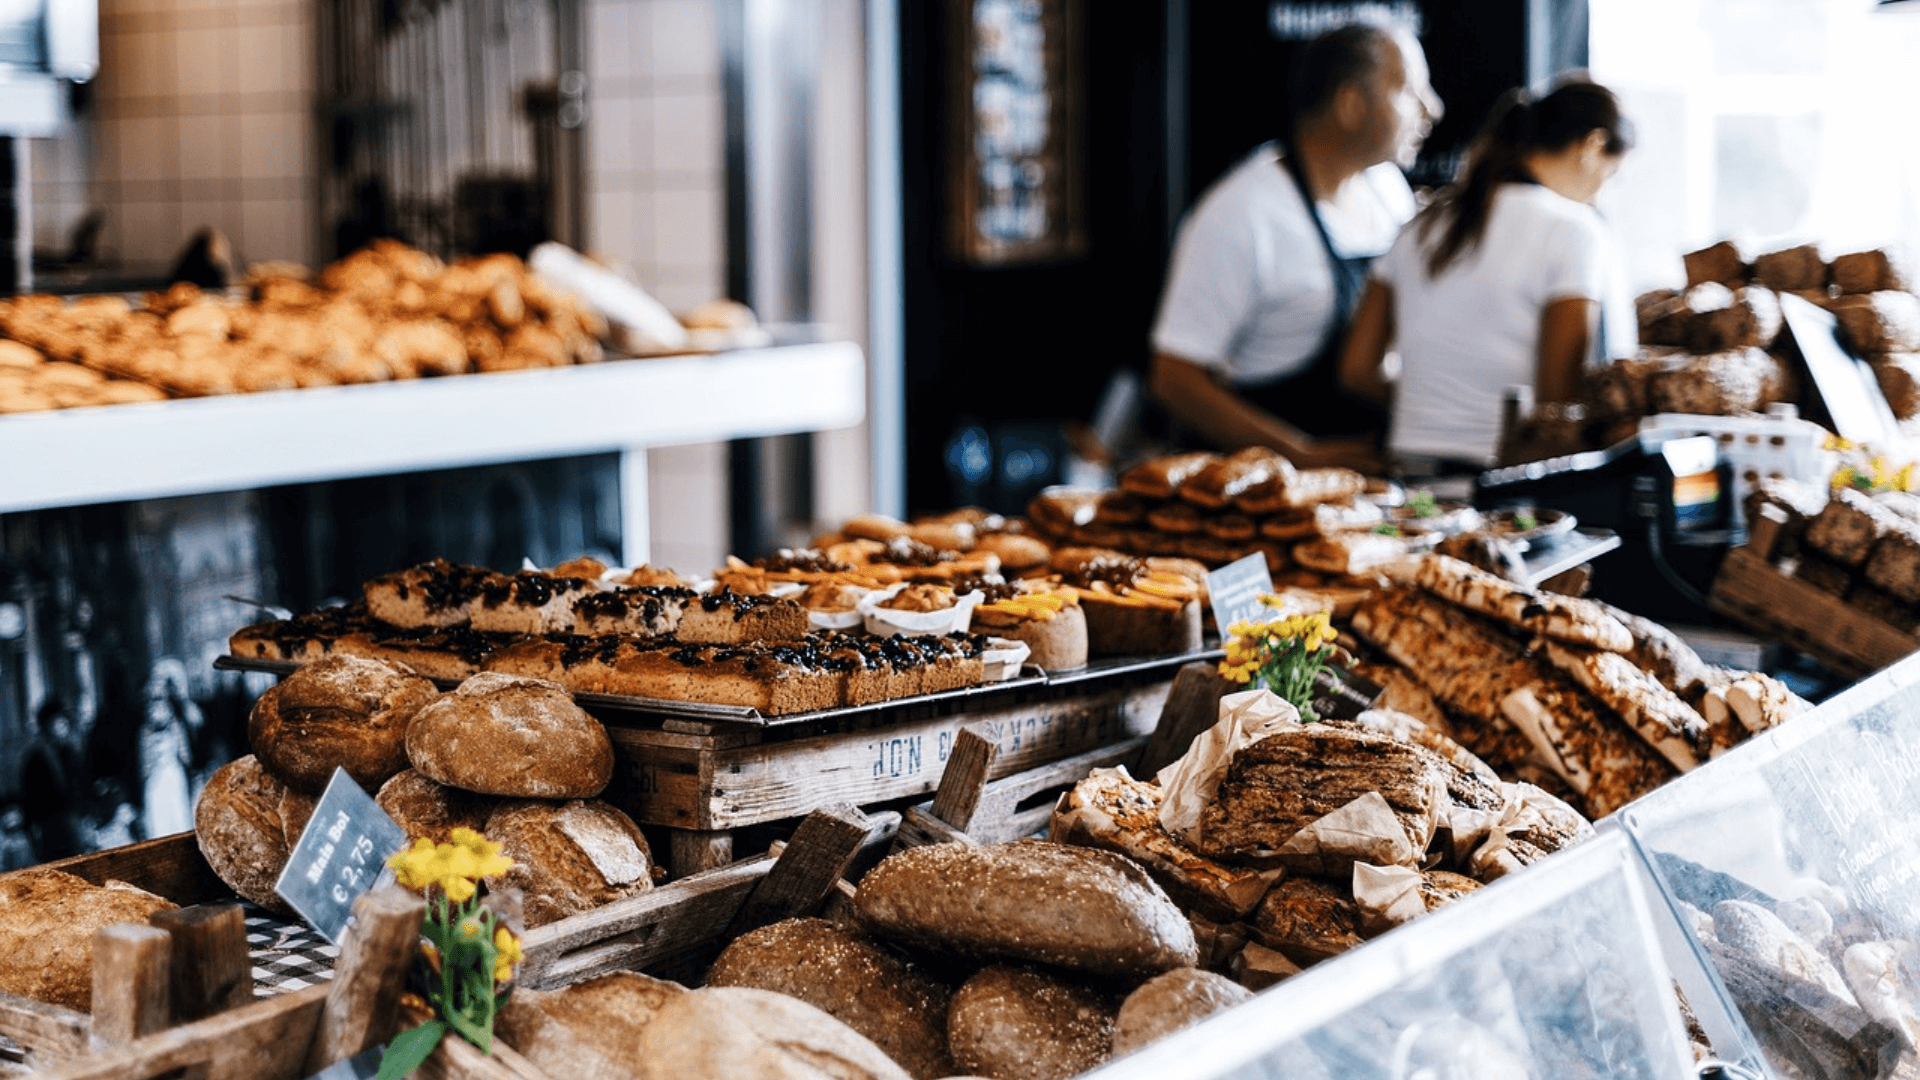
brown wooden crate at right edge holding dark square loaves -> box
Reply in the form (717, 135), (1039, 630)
(1707, 505), (1920, 678)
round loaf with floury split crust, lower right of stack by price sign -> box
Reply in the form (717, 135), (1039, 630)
(486, 799), (655, 928)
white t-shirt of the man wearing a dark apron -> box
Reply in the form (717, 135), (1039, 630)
(1154, 142), (1415, 382)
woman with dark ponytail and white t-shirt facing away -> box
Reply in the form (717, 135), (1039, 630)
(1340, 81), (1632, 463)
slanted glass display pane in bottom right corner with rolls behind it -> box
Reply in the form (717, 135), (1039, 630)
(1620, 655), (1920, 1078)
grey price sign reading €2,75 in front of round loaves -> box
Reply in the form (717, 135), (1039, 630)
(273, 769), (407, 945)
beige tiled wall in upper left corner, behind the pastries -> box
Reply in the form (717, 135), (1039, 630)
(33, 0), (317, 275)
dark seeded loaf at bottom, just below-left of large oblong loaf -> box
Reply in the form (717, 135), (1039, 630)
(707, 919), (954, 1080)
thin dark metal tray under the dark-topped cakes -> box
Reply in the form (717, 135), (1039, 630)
(213, 650), (1221, 728)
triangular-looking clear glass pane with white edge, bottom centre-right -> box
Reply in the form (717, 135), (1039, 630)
(1091, 830), (1695, 1080)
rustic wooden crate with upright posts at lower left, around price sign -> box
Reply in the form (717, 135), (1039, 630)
(0, 807), (883, 1080)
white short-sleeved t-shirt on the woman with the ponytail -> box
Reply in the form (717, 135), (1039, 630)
(1371, 184), (1636, 463)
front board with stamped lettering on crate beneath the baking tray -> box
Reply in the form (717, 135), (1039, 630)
(605, 682), (1169, 830)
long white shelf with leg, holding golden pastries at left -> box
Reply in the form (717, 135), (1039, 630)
(0, 342), (866, 565)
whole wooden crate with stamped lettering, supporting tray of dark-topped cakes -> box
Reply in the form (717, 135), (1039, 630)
(601, 669), (1173, 876)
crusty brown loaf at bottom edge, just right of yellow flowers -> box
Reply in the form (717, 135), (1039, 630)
(493, 970), (687, 1080)
